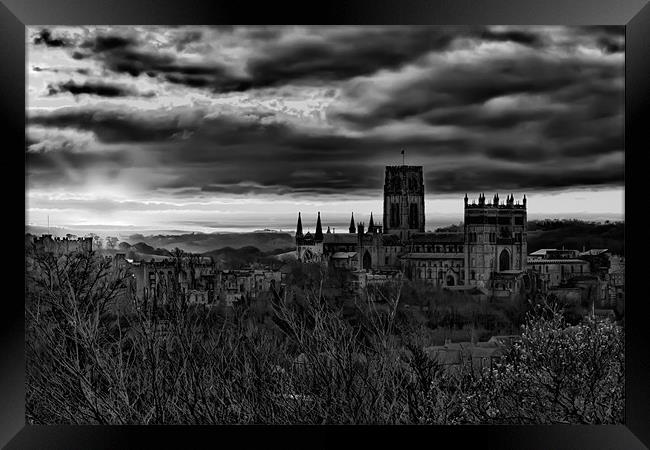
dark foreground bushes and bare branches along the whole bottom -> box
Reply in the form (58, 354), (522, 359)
(25, 251), (624, 424)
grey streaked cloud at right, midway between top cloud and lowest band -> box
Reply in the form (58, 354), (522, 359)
(332, 55), (623, 127)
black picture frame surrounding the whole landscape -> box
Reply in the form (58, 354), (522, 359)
(0, 0), (650, 450)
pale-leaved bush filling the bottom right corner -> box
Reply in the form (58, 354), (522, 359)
(456, 306), (625, 424)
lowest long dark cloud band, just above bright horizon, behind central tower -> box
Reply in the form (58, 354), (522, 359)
(30, 102), (623, 195)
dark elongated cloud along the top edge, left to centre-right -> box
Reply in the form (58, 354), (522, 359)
(60, 26), (541, 92)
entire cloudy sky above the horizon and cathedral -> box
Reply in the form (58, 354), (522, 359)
(26, 26), (625, 232)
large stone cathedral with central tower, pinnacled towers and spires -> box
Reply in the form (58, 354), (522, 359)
(296, 165), (527, 295)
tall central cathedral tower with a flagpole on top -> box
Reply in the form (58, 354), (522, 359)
(383, 165), (424, 240)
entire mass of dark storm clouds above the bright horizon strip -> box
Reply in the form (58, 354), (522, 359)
(28, 27), (624, 198)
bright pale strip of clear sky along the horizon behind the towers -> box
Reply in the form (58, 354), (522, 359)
(26, 188), (625, 236)
